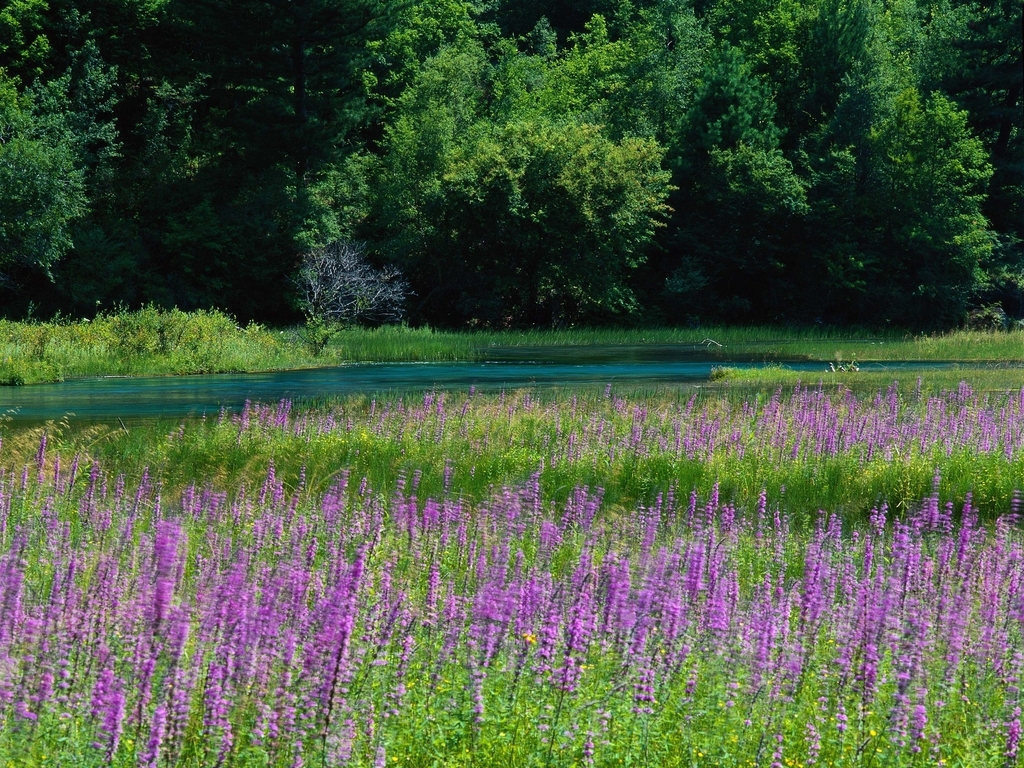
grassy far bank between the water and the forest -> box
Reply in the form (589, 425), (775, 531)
(0, 308), (1024, 385)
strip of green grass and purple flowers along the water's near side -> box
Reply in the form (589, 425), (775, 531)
(9, 384), (1024, 521)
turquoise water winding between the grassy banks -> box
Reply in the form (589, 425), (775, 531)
(0, 347), (1007, 422)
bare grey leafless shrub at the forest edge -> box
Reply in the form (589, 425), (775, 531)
(295, 241), (409, 326)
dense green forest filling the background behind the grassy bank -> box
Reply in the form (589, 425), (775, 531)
(0, 0), (1024, 330)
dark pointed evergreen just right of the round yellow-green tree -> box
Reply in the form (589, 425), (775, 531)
(666, 45), (807, 321)
